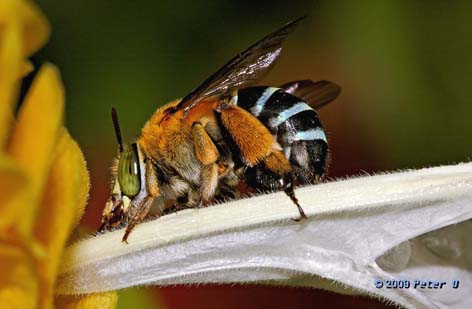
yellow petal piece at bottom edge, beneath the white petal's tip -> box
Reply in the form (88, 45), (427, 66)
(56, 292), (118, 309)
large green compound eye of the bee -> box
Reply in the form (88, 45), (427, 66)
(118, 144), (141, 197)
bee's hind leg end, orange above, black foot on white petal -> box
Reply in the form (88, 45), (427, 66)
(264, 151), (306, 221)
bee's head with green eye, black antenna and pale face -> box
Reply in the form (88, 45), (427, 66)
(98, 108), (143, 233)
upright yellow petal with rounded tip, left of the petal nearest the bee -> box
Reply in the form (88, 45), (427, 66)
(4, 64), (64, 237)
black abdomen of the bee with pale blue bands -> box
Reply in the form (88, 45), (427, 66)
(233, 86), (328, 183)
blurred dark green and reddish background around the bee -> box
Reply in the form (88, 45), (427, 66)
(33, 0), (472, 308)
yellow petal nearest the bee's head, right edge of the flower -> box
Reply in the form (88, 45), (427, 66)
(34, 129), (89, 308)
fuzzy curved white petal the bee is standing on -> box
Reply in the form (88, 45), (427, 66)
(57, 163), (472, 308)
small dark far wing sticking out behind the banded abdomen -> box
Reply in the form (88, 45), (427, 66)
(280, 79), (341, 109)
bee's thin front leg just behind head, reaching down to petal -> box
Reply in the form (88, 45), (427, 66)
(121, 159), (160, 243)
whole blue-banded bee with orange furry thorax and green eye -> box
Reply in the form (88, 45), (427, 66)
(99, 18), (340, 242)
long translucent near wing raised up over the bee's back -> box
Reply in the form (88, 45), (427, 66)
(176, 17), (305, 111)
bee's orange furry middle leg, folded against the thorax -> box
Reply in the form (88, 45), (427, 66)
(192, 122), (220, 208)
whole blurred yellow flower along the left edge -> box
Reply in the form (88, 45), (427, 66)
(0, 0), (117, 308)
